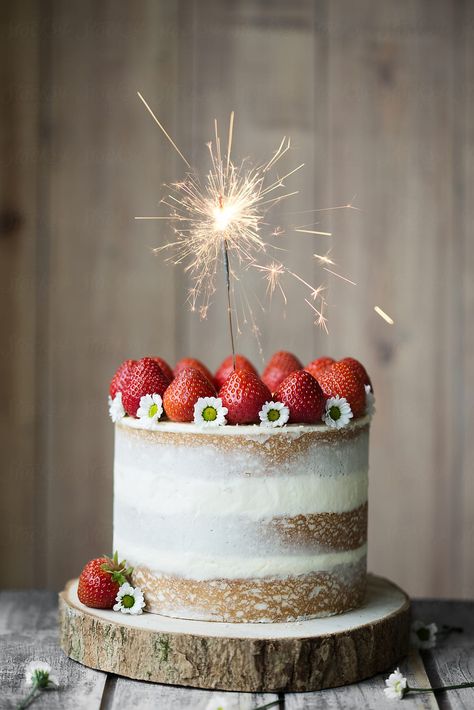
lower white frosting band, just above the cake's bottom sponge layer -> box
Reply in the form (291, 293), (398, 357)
(114, 535), (367, 580)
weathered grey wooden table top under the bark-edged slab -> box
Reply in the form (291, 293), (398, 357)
(0, 590), (474, 710)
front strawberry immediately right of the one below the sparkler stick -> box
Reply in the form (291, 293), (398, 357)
(274, 370), (326, 424)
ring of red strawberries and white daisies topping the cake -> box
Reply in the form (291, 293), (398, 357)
(109, 351), (372, 428)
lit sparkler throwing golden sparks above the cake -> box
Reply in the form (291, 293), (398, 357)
(136, 92), (386, 366)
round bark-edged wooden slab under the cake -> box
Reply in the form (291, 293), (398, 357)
(59, 575), (410, 692)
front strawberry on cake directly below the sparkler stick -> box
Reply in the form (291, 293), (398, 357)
(219, 370), (272, 424)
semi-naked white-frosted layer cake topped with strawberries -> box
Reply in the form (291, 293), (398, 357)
(105, 358), (371, 623)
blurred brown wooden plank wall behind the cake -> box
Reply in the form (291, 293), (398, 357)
(0, 0), (474, 596)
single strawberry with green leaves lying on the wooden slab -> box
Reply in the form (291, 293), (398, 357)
(77, 553), (132, 609)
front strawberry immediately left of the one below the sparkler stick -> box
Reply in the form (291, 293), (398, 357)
(163, 367), (216, 422)
